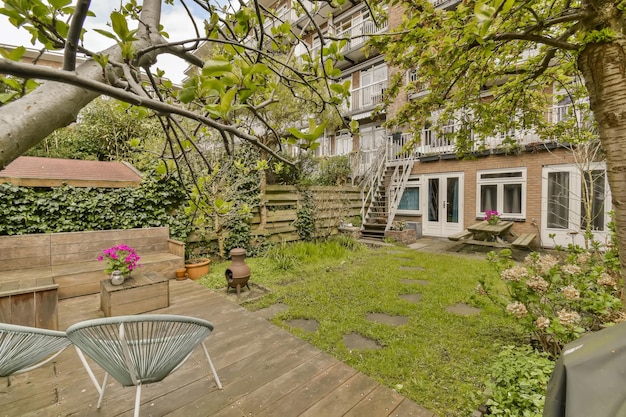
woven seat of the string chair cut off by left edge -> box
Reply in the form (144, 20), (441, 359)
(0, 323), (70, 383)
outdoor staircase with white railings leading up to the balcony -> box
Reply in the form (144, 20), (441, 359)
(361, 154), (413, 240)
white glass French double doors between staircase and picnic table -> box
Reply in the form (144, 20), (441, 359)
(422, 173), (463, 237)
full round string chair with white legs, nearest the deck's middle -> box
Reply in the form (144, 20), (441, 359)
(67, 314), (222, 416)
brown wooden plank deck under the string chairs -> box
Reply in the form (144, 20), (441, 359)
(0, 280), (435, 417)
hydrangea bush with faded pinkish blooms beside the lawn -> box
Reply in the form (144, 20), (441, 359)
(478, 246), (626, 358)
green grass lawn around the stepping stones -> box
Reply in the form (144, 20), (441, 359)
(201, 239), (523, 417)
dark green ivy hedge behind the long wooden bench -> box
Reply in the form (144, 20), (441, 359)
(0, 174), (190, 240)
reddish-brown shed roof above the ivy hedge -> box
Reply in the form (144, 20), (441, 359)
(0, 156), (141, 188)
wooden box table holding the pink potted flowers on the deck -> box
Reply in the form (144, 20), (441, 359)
(100, 272), (170, 317)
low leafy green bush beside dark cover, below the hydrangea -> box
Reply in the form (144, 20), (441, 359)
(486, 346), (554, 417)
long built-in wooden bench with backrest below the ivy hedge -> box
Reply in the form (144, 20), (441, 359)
(0, 227), (185, 299)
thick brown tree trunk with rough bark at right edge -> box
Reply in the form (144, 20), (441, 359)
(578, 40), (626, 285)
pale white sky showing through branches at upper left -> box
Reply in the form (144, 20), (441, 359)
(0, 1), (212, 83)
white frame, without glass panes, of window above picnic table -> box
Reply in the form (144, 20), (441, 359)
(476, 167), (527, 220)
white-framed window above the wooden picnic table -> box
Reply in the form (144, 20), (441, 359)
(476, 168), (526, 219)
